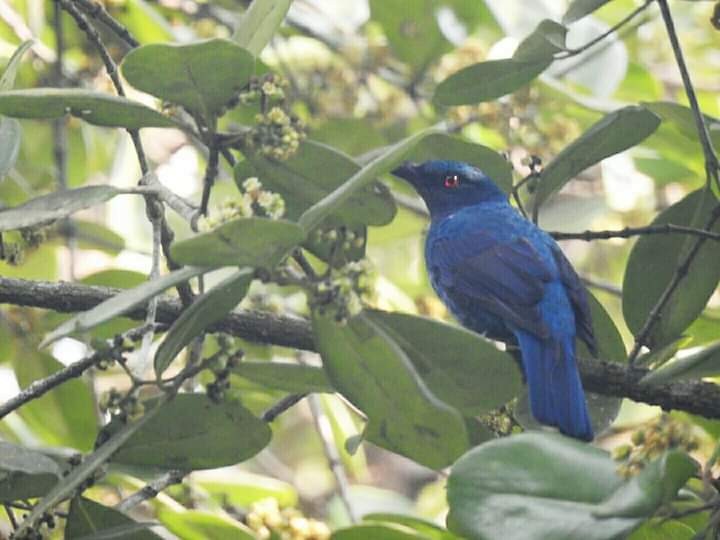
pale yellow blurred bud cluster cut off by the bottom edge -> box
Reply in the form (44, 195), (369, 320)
(245, 498), (330, 540)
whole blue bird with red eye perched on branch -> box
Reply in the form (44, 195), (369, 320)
(393, 160), (597, 440)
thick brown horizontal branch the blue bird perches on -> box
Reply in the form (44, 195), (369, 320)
(0, 278), (720, 418)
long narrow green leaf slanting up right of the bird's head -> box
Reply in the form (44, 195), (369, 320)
(535, 105), (660, 209)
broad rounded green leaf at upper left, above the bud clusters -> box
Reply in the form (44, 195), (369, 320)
(121, 38), (255, 121)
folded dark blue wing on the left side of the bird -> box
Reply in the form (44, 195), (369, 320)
(428, 231), (553, 339)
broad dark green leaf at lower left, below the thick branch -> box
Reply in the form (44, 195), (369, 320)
(111, 394), (271, 470)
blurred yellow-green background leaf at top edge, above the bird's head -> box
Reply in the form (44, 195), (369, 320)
(370, 0), (451, 70)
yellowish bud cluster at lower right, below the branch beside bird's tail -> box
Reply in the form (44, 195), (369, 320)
(613, 414), (698, 477)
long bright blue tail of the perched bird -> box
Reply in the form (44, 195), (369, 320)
(516, 331), (593, 441)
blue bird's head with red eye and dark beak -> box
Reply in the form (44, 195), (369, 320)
(392, 160), (507, 217)
